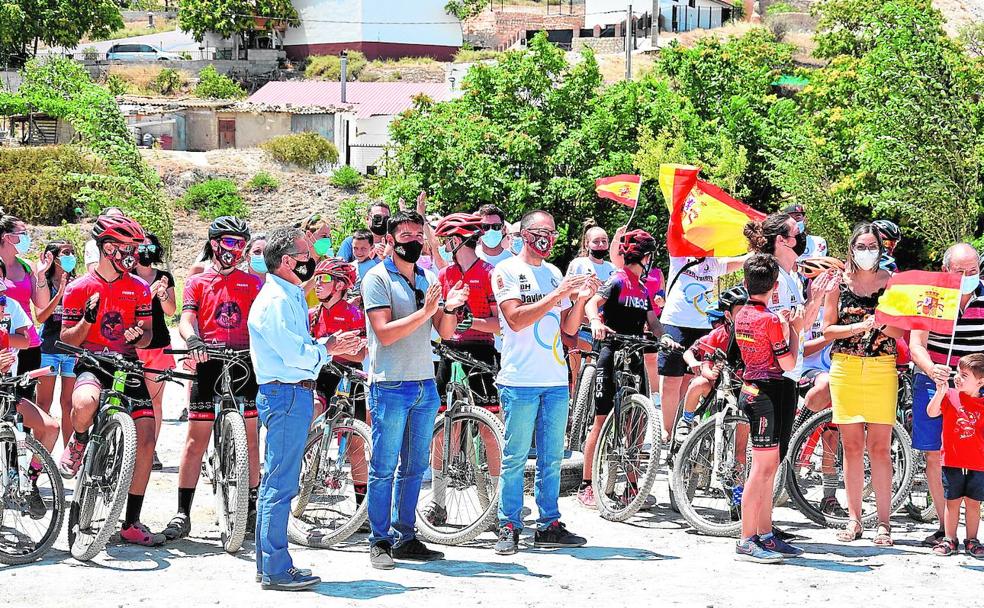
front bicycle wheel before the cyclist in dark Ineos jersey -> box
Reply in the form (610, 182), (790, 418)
(591, 394), (662, 521)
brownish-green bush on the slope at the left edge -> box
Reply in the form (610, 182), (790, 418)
(0, 146), (102, 225)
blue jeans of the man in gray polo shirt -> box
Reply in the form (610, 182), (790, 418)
(366, 380), (441, 547)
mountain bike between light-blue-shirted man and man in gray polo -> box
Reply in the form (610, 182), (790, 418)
(287, 361), (372, 548)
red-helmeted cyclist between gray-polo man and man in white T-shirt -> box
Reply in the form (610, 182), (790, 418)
(424, 213), (501, 526)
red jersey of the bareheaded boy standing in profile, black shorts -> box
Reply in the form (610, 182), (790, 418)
(735, 300), (789, 380)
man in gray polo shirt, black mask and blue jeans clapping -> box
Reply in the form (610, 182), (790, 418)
(362, 211), (468, 570)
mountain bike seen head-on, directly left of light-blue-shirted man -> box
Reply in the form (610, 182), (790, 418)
(164, 344), (252, 553)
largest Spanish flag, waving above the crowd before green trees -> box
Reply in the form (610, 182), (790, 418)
(659, 164), (765, 257)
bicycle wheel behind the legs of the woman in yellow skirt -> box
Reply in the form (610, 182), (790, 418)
(786, 409), (913, 528)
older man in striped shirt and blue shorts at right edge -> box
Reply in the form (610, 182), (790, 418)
(909, 243), (984, 546)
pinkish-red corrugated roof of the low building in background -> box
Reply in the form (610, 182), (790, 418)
(246, 81), (451, 118)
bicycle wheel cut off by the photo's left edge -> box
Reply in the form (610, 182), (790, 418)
(0, 428), (65, 565)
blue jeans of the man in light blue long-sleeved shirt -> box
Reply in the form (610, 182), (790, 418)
(256, 383), (314, 576)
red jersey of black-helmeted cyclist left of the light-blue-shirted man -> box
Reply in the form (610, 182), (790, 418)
(182, 268), (262, 350)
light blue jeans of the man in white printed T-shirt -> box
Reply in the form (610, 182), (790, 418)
(499, 384), (570, 530)
